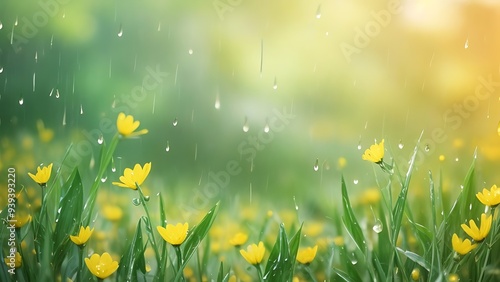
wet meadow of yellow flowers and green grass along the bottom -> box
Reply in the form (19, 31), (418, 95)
(0, 113), (500, 281)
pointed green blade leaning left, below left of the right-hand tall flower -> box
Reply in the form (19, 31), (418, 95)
(341, 176), (367, 255)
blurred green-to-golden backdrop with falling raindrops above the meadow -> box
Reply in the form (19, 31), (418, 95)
(0, 0), (500, 220)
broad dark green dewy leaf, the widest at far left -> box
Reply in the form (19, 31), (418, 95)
(53, 168), (83, 270)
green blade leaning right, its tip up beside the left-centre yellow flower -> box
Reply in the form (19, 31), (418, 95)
(175, 202), (220, 281)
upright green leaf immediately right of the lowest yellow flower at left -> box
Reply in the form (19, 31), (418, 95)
(117, 219), (146, 281)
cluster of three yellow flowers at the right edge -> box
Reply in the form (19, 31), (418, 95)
(451, 185), (500, 255)
